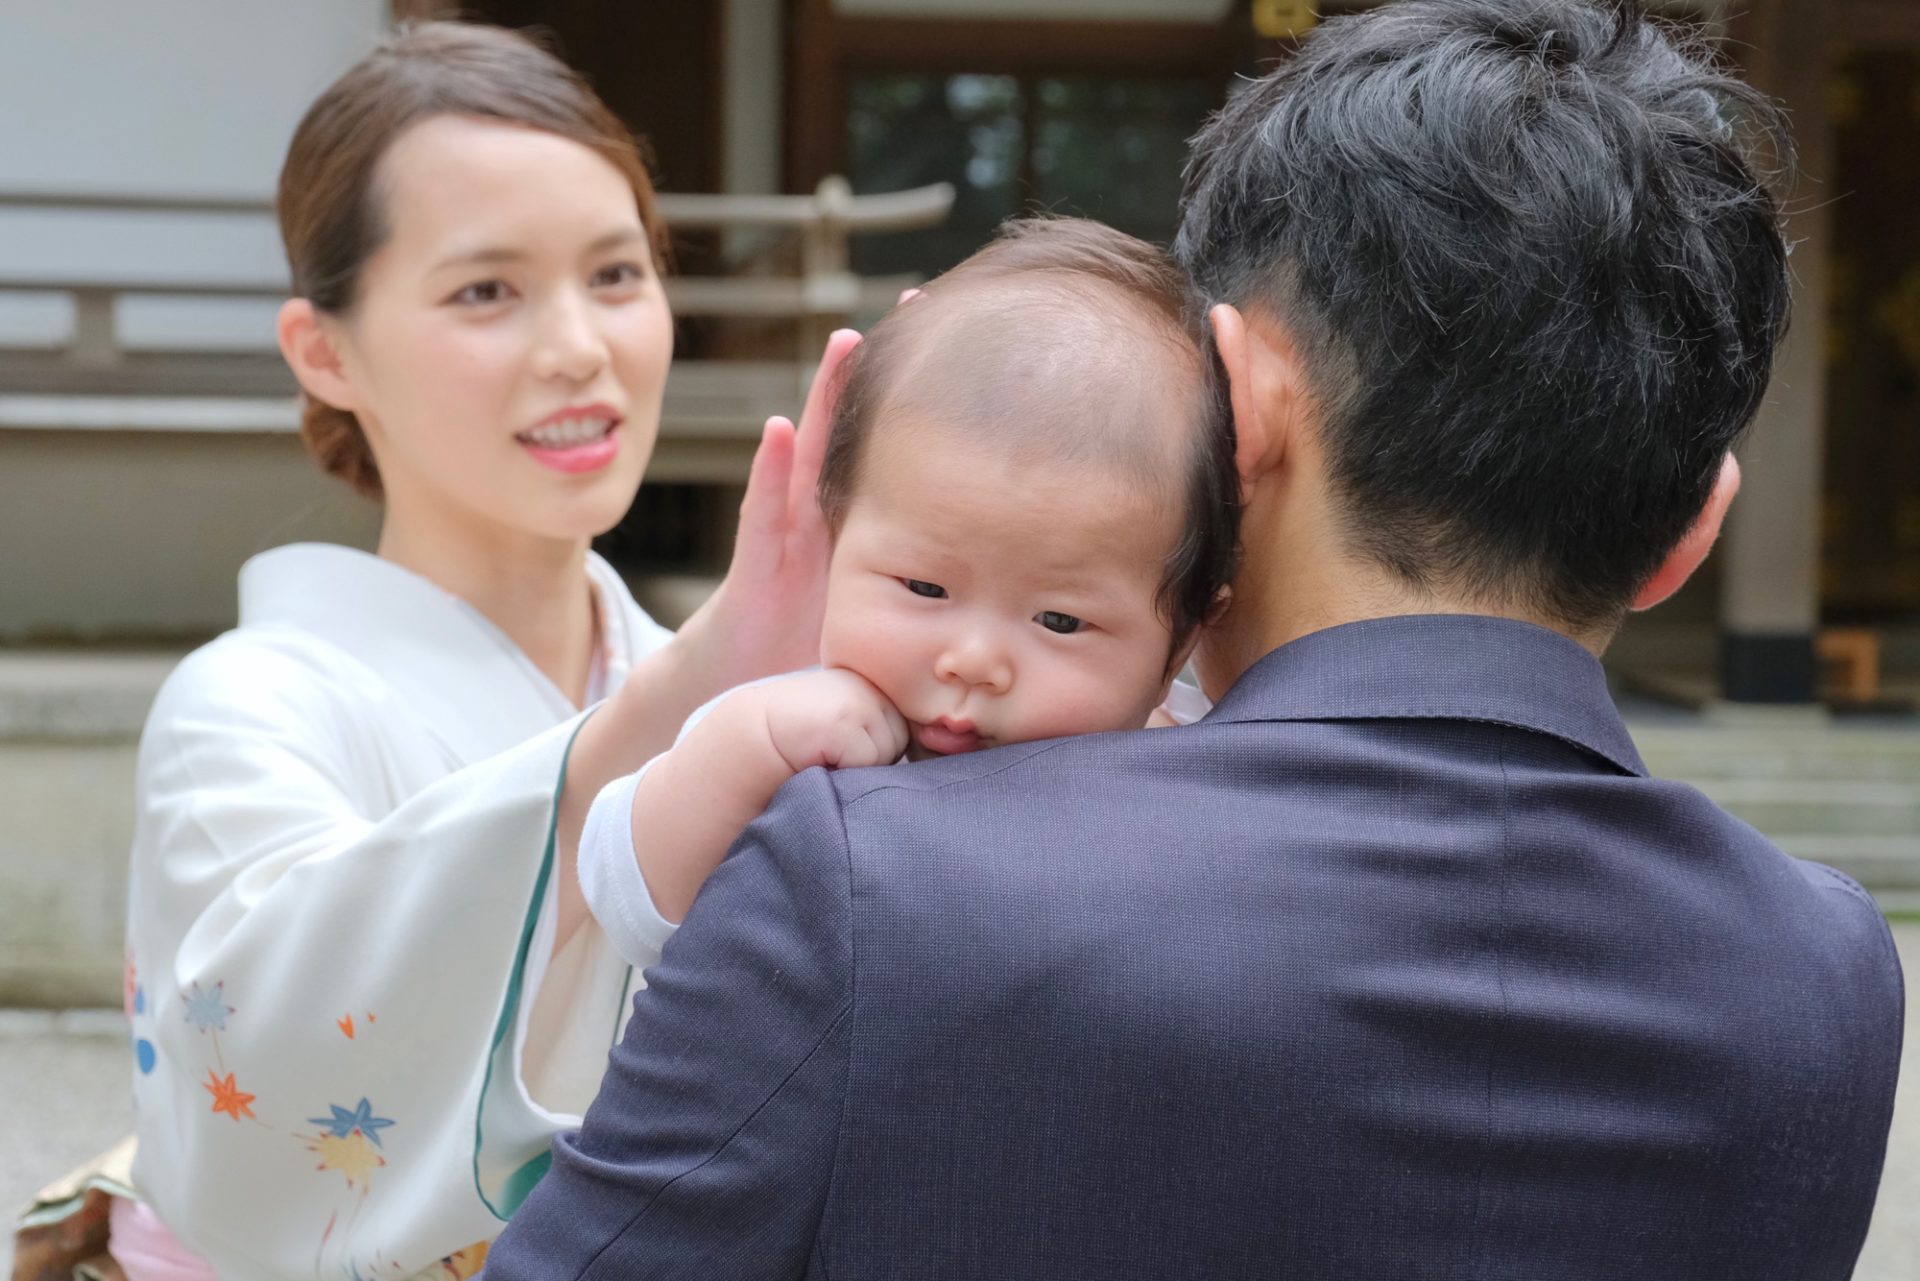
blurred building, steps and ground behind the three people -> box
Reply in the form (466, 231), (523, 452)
(0, 0), (1920, 1277)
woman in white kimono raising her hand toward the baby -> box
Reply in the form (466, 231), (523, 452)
(82, 23), (852, 1281)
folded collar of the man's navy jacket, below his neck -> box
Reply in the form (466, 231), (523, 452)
(1208, 615), (1647, 776)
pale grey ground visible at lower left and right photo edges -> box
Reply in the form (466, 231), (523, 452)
(0, 924), (1920, 1281)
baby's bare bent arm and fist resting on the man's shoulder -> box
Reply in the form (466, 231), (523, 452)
(632, 668), (906, 922)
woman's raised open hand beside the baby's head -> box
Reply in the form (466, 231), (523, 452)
(676, 328), (860, 701)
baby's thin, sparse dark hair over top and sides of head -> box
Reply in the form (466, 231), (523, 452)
(820, 217), (1238, 649)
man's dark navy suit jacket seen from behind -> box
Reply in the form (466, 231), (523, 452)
(486, 618), (1901, 1281)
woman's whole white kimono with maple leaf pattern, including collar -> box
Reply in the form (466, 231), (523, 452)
(127, 545), (670, 1281)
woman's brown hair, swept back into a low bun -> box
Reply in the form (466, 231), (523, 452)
(276, 21), (666, 499)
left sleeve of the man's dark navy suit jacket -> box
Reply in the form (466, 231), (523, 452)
(486, 768), (854, 1281)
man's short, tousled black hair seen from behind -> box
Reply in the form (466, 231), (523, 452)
(1175, 0), (1789, 628)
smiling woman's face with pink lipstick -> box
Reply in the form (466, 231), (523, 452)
(334, 115), (674, 542)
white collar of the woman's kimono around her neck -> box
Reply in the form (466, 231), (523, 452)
(240, 544), (666, 761)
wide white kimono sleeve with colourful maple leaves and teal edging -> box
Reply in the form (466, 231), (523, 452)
(129, 641), (626, 1277)
